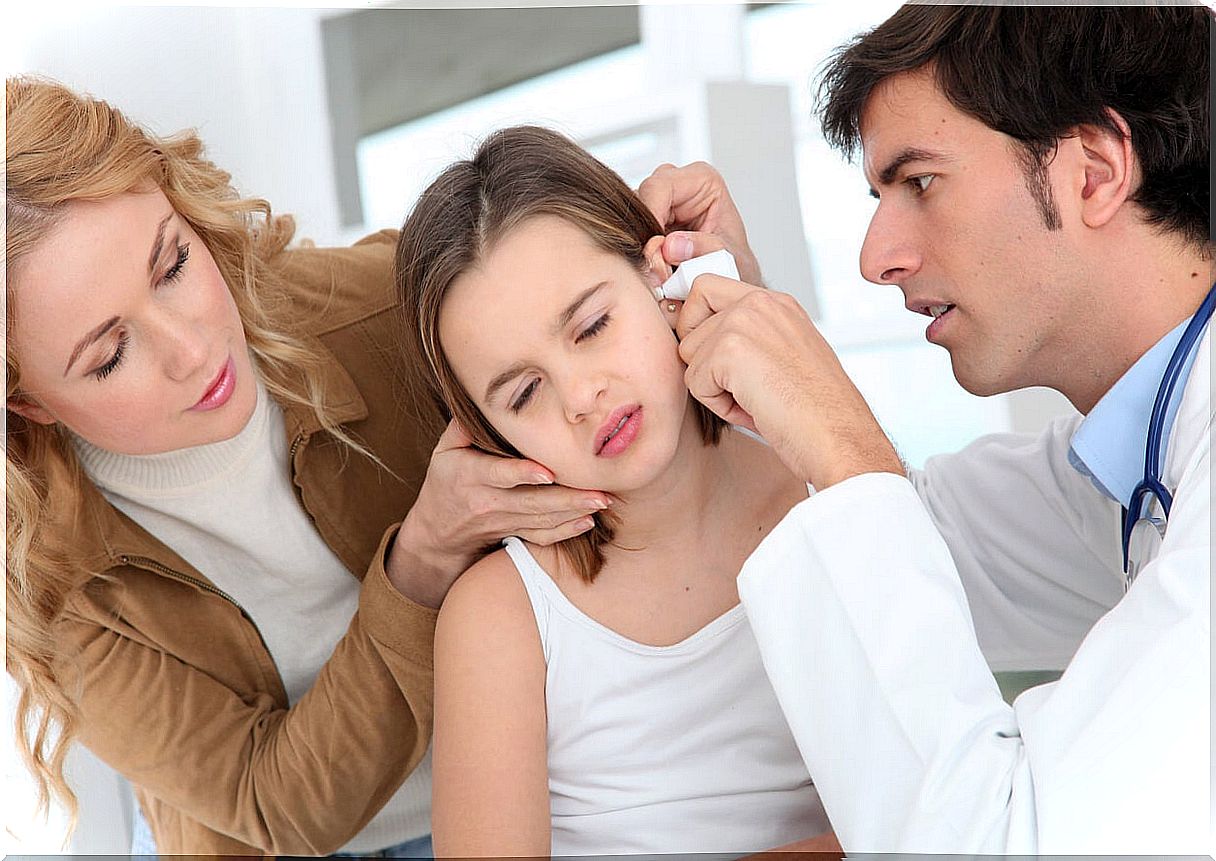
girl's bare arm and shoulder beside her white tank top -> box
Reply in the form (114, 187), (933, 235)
(432, 551), (550, 857)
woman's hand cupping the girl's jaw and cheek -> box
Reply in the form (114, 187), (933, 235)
(385, 421), (610, 607)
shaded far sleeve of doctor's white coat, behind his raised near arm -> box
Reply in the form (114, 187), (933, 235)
(911, 415), (1124, 670)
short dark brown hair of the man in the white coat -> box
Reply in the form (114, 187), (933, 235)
(818, 5), (1212, 246)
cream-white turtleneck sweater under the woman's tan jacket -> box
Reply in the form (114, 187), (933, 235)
(73, 383), (430, 852)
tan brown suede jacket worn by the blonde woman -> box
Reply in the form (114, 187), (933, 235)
(50, 231), (441, 855)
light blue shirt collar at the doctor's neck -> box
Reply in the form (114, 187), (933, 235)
(1068, 317), (1203, 508)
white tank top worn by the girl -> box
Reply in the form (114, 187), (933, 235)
(506, 538), (828, 855)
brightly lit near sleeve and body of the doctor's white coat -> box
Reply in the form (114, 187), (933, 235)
(739, 451), (1212, 854)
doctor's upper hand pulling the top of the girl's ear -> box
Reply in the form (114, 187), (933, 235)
(637, 162), (761, 283)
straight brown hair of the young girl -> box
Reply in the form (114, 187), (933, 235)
(394, 125), (725, 583)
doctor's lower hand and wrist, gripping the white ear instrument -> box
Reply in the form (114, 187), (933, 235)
(676, 275), (906, 490)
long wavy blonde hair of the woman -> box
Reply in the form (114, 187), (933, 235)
(5, 77), (362, 823)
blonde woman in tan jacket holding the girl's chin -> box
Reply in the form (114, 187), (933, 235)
(5, 79), (606, 855)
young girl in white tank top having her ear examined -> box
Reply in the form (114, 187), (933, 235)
(396, 128), (827, 856)
